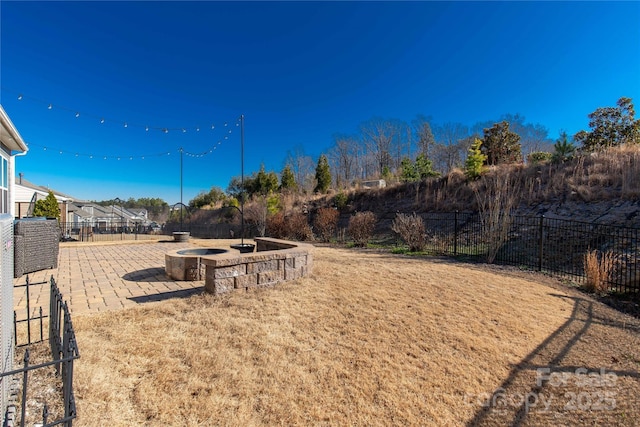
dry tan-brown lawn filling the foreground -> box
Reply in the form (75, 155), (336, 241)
(67, 248), (640, 426)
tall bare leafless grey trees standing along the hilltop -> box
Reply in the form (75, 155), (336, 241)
(285, 114), (553, 191)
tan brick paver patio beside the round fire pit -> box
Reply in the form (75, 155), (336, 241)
(13, 241), (204, 318)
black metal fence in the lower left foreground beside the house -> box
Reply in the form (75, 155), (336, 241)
(0, 276), (80, 427)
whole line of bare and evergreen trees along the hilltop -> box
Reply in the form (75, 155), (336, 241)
(184, 98), (640, 207)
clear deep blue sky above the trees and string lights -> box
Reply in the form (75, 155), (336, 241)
(0, 0), (640, 204)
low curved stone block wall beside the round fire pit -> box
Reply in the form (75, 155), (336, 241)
(200, 237), (313, 294)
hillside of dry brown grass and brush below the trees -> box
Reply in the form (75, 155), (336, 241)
(175, 145), (640, 238)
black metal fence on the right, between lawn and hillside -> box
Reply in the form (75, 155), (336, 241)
(422, 212), (640, 293)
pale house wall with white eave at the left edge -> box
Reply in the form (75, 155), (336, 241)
(0, 105), (28, 414)
